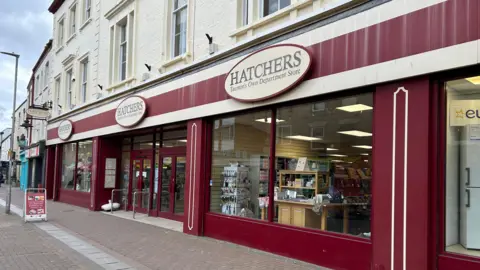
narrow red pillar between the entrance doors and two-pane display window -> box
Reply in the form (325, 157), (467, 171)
(183, 119), (207, 235)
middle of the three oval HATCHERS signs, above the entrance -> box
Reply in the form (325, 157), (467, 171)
(115, 96), (147, 127)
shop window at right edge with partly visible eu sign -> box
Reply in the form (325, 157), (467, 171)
(445, 76), (480, 257)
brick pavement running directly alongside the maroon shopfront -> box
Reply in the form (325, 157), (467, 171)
(0, 187), (325, 270)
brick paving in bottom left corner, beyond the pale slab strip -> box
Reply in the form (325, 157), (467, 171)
(0, 207), (102, 270)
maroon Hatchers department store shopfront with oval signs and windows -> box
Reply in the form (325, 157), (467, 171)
(47, 0), (480, 270)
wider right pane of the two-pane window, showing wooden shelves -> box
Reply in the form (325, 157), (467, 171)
(274, 94), (373, 238)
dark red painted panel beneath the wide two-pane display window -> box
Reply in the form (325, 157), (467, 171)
(204, 213), (372, 270)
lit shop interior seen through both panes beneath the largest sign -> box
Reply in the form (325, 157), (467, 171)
(210, 94), (373, 238)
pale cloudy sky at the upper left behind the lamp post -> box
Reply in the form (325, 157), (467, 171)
(0, 0), (53, 131)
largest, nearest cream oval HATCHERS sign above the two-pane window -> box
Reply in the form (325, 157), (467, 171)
(225, 44), (312, 102)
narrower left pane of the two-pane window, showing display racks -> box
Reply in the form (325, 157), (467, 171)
(210, 111), (271, 220)
